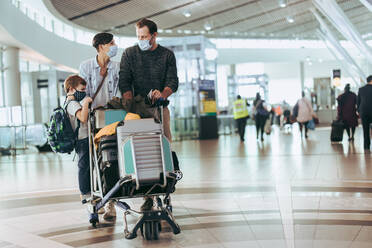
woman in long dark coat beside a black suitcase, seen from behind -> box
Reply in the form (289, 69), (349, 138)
(337, 84), (358, 141)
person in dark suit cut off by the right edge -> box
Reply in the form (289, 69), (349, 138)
(357, 75), (372, 150)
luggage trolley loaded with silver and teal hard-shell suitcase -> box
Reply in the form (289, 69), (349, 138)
(83, 100), (182, 240)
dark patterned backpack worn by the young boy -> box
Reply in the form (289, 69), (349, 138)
(47, 99), (80, 154)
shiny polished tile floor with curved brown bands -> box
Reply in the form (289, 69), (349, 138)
(0, 126), (372, 248)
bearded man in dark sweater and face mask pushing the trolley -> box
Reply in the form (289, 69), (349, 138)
(119, 19), (178, 211)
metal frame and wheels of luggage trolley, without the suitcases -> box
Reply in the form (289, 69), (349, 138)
(83, 103), (181, 240)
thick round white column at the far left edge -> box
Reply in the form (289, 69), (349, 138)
(3, 47), (22, 107)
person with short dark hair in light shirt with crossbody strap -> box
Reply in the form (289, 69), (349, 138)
(79, 33), (120, 220)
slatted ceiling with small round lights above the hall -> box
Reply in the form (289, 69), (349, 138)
(44, 0), (372, 39)
